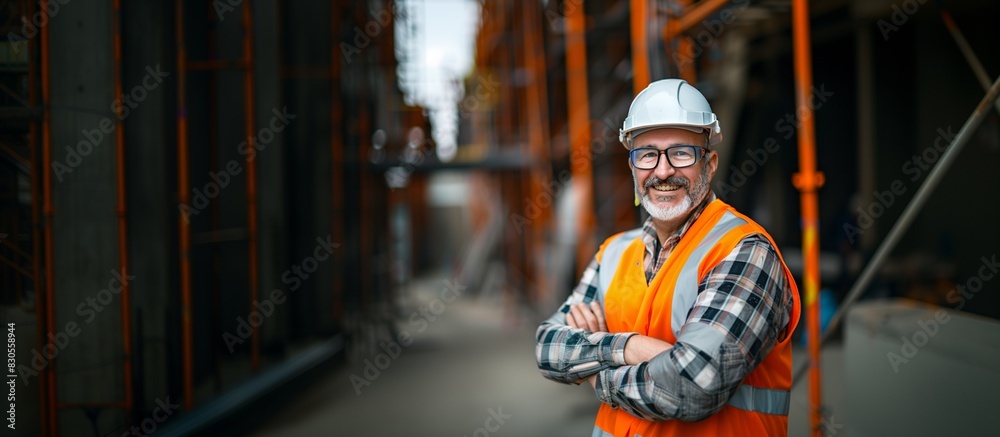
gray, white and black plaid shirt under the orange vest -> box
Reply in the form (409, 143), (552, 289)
(535, 194), (793, 421)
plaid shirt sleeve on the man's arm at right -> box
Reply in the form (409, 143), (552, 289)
(595, 235), (793, 421)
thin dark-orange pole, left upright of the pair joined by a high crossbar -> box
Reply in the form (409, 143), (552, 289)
(174, 1), (194, 411)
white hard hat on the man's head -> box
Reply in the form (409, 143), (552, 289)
(618, 79), (722, 149)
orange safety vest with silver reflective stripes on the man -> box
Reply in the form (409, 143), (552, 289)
(593, 199), (800, 437)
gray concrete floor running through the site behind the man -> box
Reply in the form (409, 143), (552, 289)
(253, 280), (849, 437)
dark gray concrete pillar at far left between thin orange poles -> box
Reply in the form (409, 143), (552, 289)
(48, 0), (125, 430)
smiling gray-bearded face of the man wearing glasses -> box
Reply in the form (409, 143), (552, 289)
(629, 129), (719, 228)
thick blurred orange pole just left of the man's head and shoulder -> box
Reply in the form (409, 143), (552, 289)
(566, 0), (595, 271)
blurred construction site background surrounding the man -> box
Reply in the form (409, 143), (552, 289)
(0, 0), (1000, 436)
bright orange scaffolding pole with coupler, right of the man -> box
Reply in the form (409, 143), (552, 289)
(792, 0), (823, 437)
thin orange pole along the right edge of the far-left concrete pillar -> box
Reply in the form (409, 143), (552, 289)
(112, 0), (132, 423)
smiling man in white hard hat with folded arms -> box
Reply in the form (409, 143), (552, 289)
(535, 79), (799, 437)
